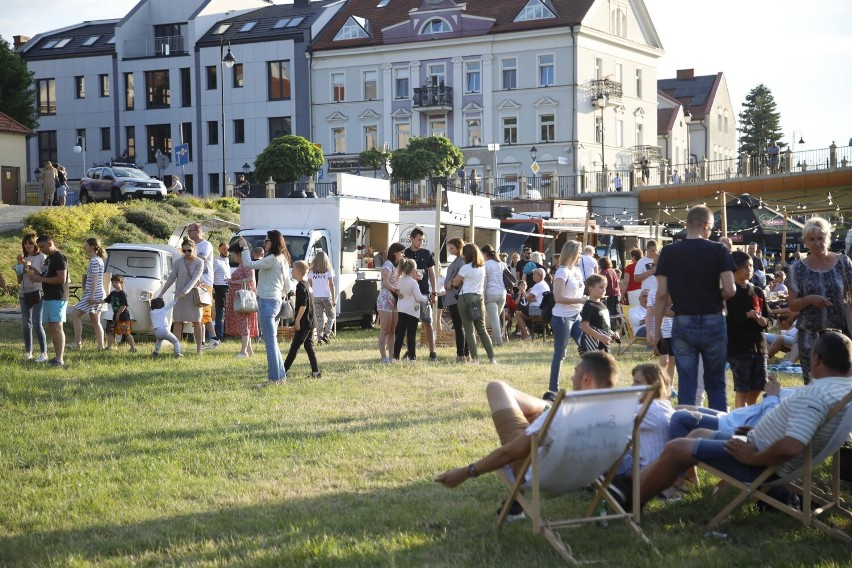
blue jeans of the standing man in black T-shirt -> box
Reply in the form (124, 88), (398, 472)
(672, 314), (728, 412)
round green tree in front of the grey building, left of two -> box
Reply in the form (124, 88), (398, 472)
(254, 135), (325, 183)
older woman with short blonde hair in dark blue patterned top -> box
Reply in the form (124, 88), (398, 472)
(787, 217), (852, 384)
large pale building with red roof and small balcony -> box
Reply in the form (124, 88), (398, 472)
(311, 0), (662, 197)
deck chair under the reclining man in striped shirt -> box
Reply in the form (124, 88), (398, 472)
(698, 392), (852, 543)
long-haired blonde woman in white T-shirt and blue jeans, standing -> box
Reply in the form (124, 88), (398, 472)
(544, 241), (587, 400)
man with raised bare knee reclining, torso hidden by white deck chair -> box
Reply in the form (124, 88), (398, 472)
(435, 351), (618, 517)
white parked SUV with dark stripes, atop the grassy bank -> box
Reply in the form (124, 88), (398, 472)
(80, 164), (166, 204)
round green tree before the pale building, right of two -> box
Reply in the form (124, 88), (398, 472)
(391, 136), (464, 181)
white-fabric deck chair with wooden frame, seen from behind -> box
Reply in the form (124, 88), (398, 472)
(497, 384), (660, 563)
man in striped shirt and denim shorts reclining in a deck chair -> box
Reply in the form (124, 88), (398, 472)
(613, 330), (852, 507)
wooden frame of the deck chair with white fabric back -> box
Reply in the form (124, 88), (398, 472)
(497, 383), (661, 564)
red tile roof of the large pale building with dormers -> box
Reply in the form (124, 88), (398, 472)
(313, 0), (595, 50)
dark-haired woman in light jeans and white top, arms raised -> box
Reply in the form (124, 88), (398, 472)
(239, 231), (290, 385)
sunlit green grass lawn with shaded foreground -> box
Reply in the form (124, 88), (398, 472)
(0, 322), (852, 567)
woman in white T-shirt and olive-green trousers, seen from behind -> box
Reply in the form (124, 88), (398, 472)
(453, 243), (497, 363)
